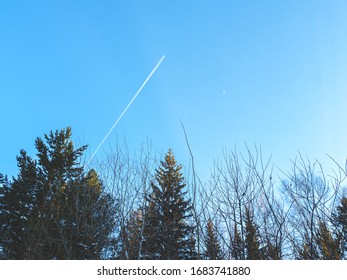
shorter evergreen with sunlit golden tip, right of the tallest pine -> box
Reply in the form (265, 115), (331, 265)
(52, 169), (115, 259)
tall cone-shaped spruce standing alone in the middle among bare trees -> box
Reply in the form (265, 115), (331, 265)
(143, 149), (196, 260)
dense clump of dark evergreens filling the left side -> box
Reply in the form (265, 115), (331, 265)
(0, 128), (114, 259)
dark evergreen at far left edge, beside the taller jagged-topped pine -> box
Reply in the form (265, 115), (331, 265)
(0, 150), (41, 259)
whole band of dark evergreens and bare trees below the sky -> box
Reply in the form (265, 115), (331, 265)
(0, 127), (347, 260)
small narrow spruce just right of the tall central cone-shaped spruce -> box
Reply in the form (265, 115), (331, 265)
(204, 218), (222, 260)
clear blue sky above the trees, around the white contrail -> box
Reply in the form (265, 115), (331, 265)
(0, 0), (347, 183)
